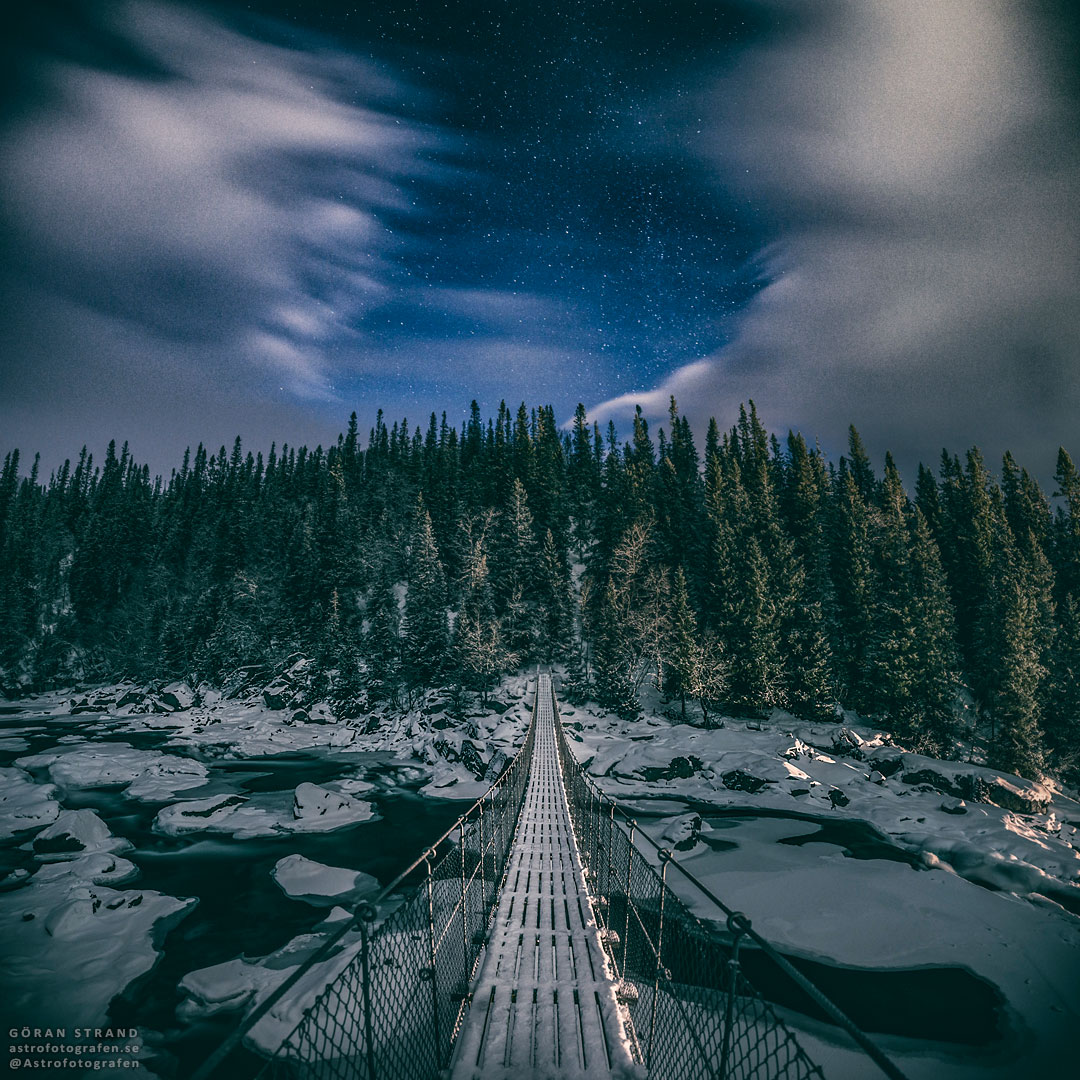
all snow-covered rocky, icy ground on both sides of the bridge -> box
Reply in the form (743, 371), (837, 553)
(0, 676), (1080, 1080)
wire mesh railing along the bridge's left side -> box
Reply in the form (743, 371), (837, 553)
(193, 680), (539, 1080)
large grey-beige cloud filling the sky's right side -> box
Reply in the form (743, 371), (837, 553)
(592, 0), (1080, 474)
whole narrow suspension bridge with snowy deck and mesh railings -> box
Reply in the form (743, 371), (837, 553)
(195, 673), (903, 1080)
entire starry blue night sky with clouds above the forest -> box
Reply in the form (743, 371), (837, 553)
(0, 0), (1080, 477)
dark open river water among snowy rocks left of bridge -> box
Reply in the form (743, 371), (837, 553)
(0, 714), (468, 1076)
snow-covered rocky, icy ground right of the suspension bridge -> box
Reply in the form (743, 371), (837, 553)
(563, 706), (1080, 1080)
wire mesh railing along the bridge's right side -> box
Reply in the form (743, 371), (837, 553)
(552, 692), (904, 1080)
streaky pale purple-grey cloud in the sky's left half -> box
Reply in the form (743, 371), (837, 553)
(0, 0), (458, 434)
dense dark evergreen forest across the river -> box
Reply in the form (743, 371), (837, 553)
(0, 401), (1080, 775)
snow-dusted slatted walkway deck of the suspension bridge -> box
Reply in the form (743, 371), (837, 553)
(450, 675), (632, 1080)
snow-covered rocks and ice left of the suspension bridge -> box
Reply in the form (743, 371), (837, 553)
(0, 673), (529, 1071)
